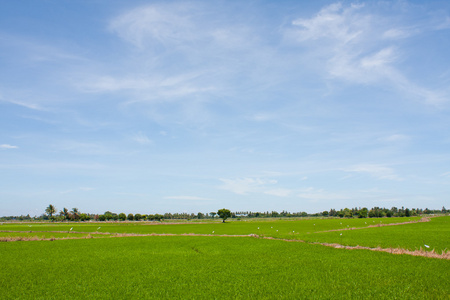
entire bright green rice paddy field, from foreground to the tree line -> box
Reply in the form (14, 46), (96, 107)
(0, 216), (450, 299)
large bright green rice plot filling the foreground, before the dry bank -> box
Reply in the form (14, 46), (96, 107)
(0, 236), (450, 299)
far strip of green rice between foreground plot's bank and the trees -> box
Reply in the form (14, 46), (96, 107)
(0, 217), (420, 239)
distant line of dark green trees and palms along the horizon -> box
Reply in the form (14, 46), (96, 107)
(0, 204), (450, 221)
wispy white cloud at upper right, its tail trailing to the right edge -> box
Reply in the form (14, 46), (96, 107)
(286, 3), (449, 105)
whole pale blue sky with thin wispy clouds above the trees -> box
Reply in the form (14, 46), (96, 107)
(0, 0), (450, 215)
